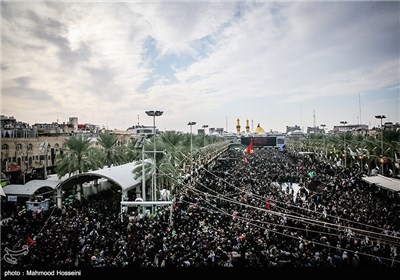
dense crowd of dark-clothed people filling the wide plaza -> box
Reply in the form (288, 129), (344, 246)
(1, 149), (400, 269)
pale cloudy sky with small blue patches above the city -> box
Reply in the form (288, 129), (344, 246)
(1, 1), (400, 132)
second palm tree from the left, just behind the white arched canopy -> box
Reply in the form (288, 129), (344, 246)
(97, 133), (125, 167)
